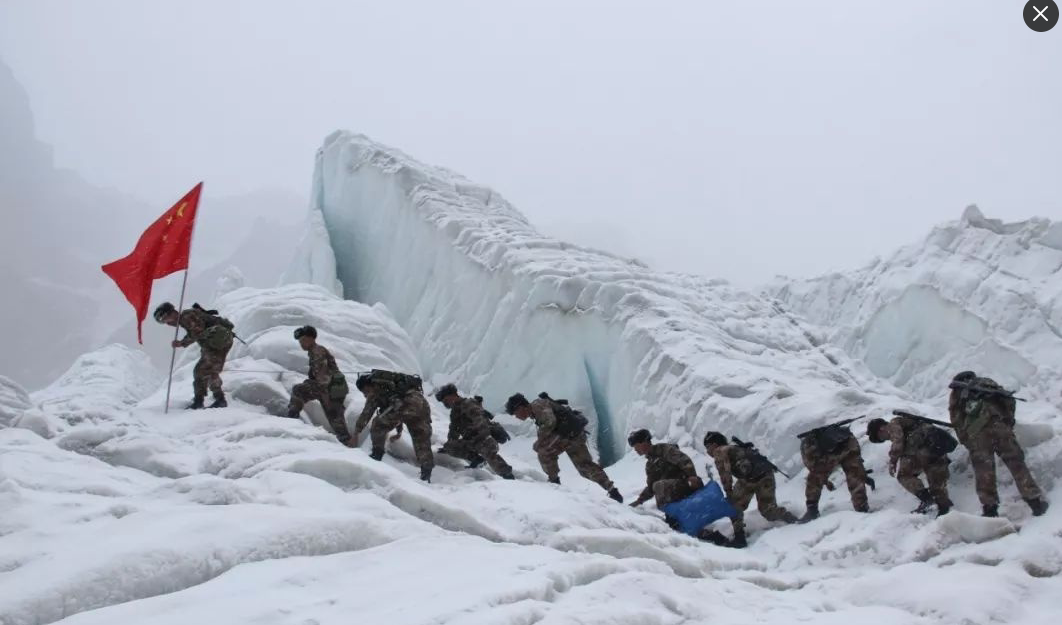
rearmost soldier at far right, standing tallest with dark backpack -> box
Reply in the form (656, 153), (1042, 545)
(947, 371), (1048, 517)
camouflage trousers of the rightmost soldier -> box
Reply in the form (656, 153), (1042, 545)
(964, 421), (1042, 506)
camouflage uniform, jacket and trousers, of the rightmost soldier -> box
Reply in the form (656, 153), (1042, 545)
(947, 378), (1042, 507)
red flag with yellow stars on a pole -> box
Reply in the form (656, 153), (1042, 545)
(103, 183), (203, 343)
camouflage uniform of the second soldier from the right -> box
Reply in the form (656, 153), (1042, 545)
(885, 417), (952, 509)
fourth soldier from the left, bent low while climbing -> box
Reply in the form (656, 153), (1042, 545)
(435, 384), (515, 480)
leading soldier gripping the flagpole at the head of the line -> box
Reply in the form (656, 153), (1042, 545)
(155, 301), (233, 410)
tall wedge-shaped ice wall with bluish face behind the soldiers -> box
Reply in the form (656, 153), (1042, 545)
(293, 133), (894, 461)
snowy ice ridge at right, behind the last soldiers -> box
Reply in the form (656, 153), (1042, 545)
(768, 207), (1062, 410)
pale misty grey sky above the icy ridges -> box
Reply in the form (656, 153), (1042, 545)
(0, 0), (1062, 284)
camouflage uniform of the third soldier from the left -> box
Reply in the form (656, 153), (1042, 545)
(354, 389), (435, 471)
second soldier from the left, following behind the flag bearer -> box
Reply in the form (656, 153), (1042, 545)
(288, 326), (355, 447)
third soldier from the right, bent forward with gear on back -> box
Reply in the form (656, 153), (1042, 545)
(799, 419), (873, 523)
